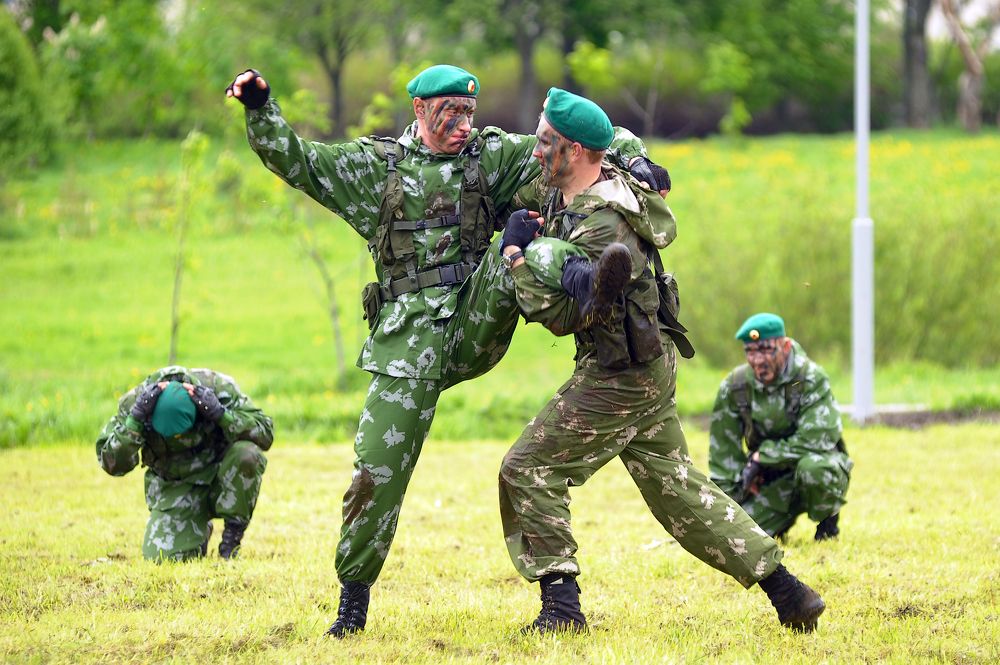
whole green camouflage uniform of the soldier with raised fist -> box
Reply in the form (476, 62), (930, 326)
(246, 98), (645, 585)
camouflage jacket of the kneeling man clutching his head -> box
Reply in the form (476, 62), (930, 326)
(96, 365), (274, 484)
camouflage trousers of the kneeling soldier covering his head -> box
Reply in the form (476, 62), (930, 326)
(142, 441), (267, 561)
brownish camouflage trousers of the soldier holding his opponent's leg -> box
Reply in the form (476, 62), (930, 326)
(500, 342), (782, 587)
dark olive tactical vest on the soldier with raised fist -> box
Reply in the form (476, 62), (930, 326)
(362, 136), (498, 312)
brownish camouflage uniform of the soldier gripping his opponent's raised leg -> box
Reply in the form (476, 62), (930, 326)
(500, 163), (782, 587)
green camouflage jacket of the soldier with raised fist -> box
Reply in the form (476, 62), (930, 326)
(246, 99), (645, 379)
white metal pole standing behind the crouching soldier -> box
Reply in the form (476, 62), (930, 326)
(851, 0), (875, 423)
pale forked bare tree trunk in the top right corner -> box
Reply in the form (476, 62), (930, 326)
(941, 0), (1000, 132)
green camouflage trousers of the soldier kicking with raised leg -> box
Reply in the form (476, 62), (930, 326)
(336, 237), (518, 585)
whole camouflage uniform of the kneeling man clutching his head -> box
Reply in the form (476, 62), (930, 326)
(96, 366), (274, 561)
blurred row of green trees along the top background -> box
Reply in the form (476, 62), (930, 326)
(0, 0), (1000, 149)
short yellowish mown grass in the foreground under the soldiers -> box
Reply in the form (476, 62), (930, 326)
(0, 425), (1000, 663)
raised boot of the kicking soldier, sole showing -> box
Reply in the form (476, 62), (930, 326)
(561, 242), (632, 318)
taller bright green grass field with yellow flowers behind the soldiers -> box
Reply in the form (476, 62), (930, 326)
(0, 130), (1000, 447)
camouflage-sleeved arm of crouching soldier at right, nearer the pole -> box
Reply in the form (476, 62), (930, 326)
(758, 367), (841, 466)
